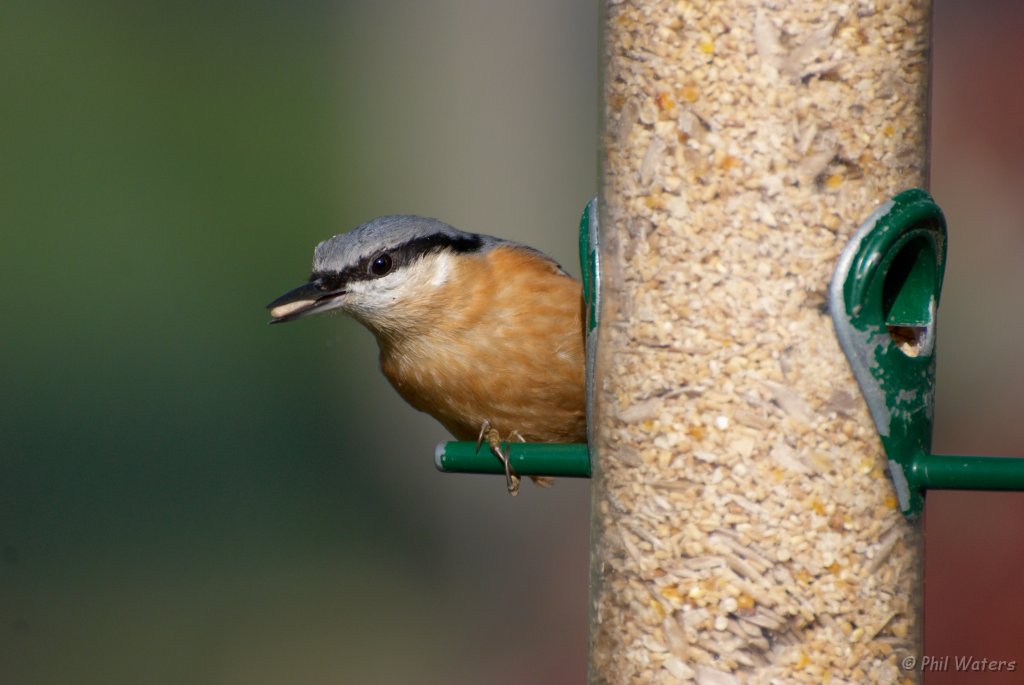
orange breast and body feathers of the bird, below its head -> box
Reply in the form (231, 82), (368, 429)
(381, 246), (587, 442)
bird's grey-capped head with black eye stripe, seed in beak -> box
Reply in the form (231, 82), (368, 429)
(267, 215), (487, 336)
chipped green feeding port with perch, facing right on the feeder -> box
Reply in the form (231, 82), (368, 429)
(829, 189), (1024, 517)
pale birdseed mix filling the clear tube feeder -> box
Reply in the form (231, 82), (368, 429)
(591, 0), (931, 685)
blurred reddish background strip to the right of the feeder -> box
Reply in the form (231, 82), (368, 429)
(925, 0), (1024, 685)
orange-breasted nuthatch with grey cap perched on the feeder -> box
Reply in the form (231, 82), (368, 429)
(267, 215), (587, 496)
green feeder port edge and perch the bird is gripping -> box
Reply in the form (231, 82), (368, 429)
(434, 198), (601, 478)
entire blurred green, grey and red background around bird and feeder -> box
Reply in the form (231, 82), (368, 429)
(0, 0), (1024, 685)
